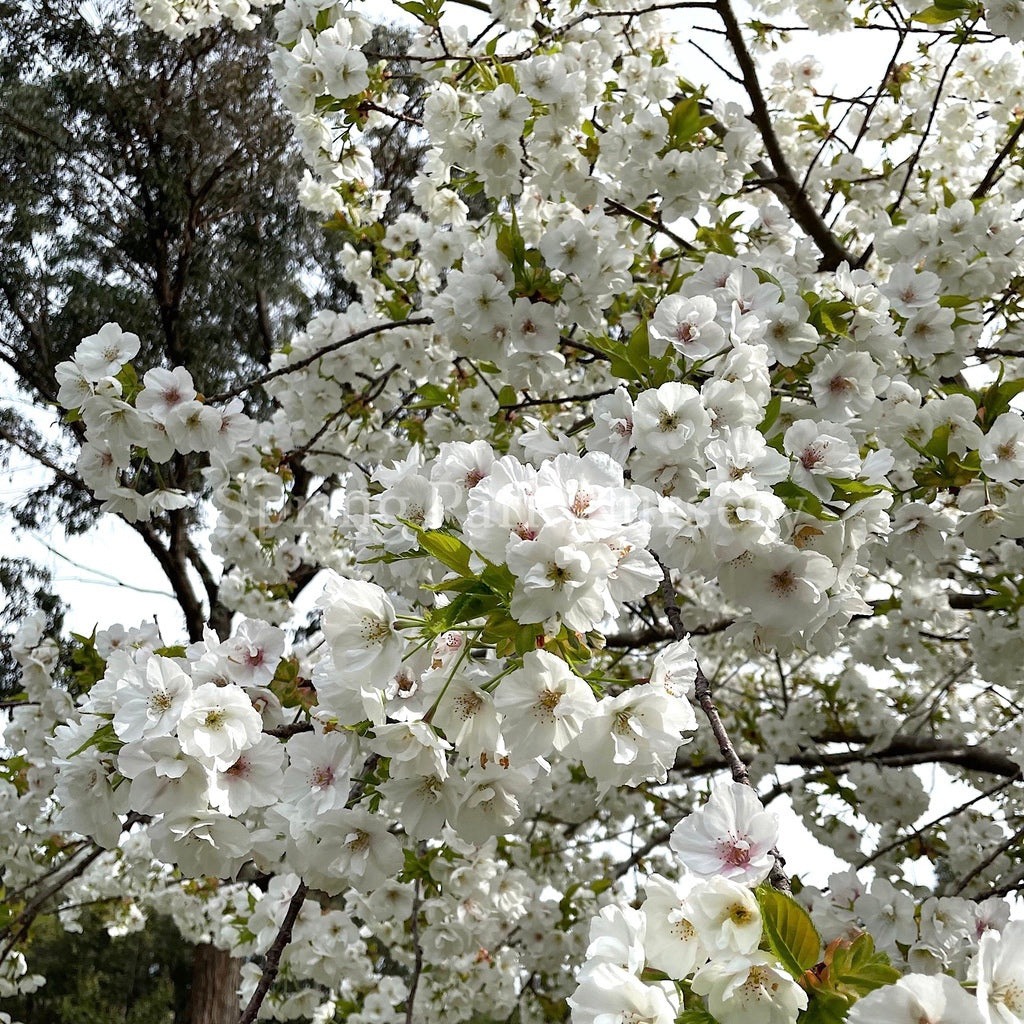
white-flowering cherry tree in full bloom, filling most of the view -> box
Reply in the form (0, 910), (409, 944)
(0, 0), (1024, 1024)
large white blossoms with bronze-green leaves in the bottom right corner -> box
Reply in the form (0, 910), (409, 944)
(568, 782), (1024, 1024)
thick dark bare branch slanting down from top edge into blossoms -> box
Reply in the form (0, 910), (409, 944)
(715, 0), (854, 270)
